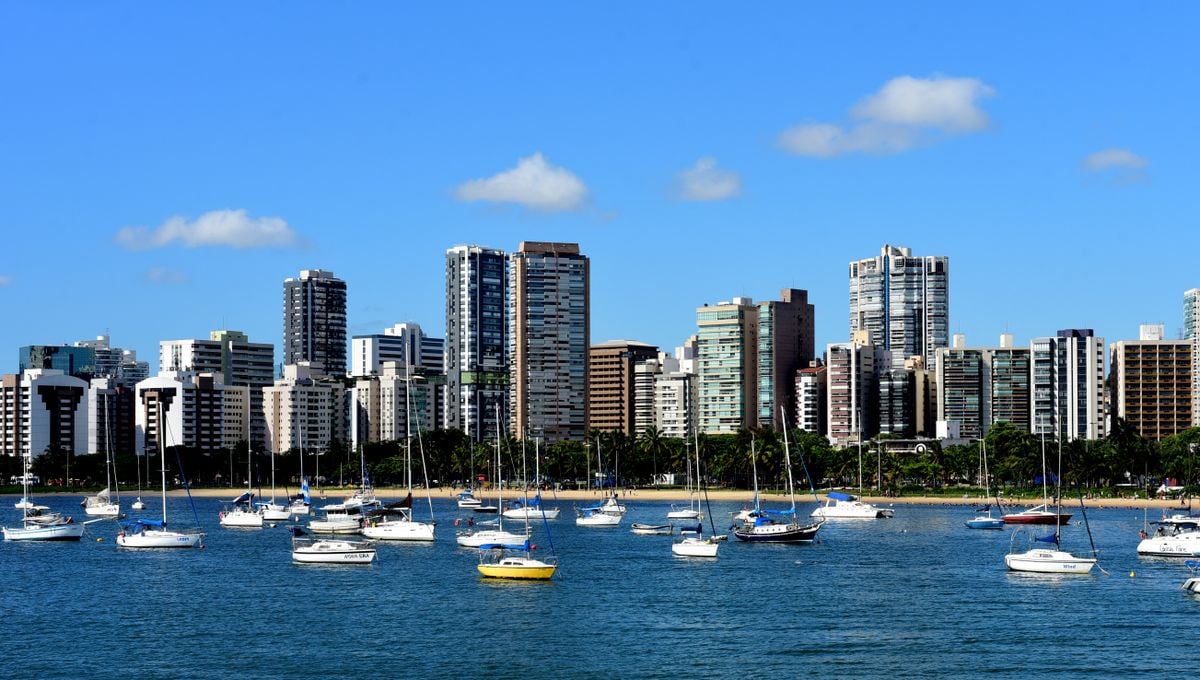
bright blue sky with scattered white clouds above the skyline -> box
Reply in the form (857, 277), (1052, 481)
(0, 2), (1200, 372)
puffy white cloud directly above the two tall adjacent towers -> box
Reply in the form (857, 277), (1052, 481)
(455, 152), (588, 212)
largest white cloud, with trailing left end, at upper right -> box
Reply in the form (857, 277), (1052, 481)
(779, 76), (995, 158)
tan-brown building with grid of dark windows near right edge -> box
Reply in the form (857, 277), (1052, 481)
(1111, 325), (1193, 439)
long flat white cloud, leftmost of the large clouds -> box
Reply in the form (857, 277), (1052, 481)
(115, 210), (296, 251)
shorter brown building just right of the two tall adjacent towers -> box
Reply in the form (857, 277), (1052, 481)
(588, 341), (659, 434)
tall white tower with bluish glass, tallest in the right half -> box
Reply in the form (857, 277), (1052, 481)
(850, 246), (950, 367)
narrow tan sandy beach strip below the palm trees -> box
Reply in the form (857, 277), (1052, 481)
(0, 487), (1188, 511)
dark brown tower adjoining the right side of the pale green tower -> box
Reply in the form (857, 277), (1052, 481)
(756, 288), (816, 428)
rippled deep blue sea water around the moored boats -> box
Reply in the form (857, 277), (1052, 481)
(0, 495), (1200, 680)
